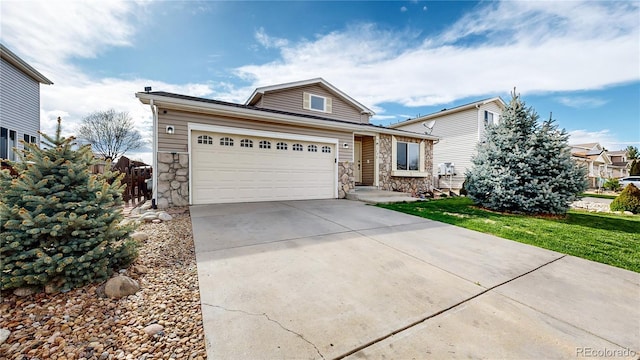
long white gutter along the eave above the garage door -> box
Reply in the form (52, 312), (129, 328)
(136, 93), (439, 140)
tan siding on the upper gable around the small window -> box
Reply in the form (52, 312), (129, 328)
(260, 85), (369, 123)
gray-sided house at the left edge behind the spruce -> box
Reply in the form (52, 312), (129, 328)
(0, 44), (53, 160)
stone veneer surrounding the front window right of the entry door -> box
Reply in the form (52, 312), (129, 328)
(378, 134), (433, 196)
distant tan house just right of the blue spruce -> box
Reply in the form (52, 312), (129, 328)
(569, 143), (614, 188)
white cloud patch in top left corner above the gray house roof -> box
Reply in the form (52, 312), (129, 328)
(2, 0), (142, 77)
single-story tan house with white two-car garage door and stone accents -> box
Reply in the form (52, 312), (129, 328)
(136, 78), (437, 208)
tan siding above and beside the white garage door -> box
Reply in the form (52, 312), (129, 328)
(158, 109), (353, 161)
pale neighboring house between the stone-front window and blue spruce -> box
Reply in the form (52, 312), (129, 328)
(389, 97), (506, 189)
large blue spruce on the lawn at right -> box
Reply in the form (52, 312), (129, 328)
(466, 90), (586, 214)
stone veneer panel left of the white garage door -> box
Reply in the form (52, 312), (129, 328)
(154, 153), (189, 209)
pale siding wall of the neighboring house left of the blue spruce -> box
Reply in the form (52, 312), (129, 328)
(398, 108), (480, 176)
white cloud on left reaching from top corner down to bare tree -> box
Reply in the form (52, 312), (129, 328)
(1, 0), (218, 159)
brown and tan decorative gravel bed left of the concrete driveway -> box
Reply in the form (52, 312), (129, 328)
(0, 208), (207, 360)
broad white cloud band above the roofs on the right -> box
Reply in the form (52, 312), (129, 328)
(236, 1), (640, 107)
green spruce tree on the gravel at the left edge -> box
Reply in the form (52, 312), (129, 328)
(0, 118), (137, 290)
